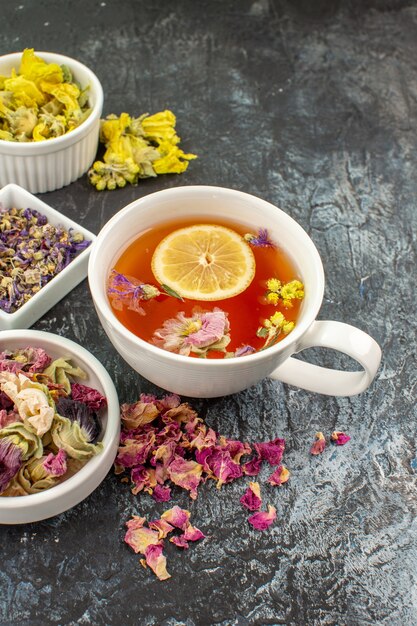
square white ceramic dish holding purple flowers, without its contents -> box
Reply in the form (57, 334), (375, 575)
(0, 184), (96, 330)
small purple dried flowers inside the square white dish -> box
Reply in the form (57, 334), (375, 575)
(0, 208), (91, 313)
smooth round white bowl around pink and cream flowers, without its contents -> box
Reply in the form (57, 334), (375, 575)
(0, 330), (120, 524)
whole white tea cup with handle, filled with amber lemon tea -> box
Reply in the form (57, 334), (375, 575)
(88, 186), (381, 398)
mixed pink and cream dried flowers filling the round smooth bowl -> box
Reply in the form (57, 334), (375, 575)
(0, 347), (106, 496)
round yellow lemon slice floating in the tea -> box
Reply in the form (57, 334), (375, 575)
(152, 224), (255, 300)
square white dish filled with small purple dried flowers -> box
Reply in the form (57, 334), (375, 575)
(0, 184), (96, 330)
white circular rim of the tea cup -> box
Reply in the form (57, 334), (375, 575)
(88, 185), (325, 370)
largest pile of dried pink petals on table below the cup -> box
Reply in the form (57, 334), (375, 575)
(115, 394), (285, 501)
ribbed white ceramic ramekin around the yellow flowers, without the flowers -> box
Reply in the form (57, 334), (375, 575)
(0, 52), (103, 193)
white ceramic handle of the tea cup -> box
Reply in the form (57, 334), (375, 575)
(270, 321), (381, 396)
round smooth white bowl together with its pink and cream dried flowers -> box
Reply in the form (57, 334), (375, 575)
(0, 330), (120, 524)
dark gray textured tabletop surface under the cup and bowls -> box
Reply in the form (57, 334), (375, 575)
(0, 0), (417, 626)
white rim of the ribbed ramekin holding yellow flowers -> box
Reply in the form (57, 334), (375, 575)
(0, 50), (104, 156)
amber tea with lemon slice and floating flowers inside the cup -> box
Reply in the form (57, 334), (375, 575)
(107, 219), (304, 358)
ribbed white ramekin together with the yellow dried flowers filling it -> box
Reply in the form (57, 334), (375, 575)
(0, 48), (103, 193)
